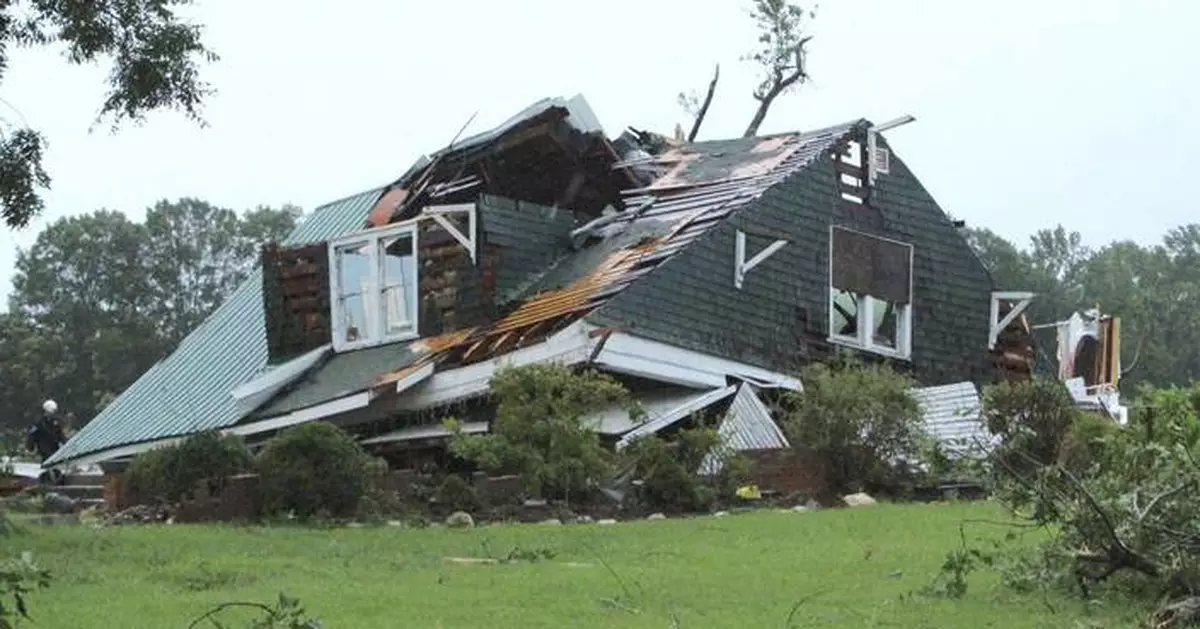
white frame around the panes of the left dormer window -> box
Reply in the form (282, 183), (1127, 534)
(329, 221), (421, 352)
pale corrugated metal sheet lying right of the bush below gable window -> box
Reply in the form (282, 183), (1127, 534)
(912, 382), (994, 456)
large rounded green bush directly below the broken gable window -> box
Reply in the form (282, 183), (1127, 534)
(779, 357), (924, 492)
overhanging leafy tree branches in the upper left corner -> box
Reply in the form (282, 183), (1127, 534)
(0, 0), (217, 228)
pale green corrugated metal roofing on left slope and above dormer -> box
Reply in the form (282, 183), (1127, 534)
(47, 188), (380, 463)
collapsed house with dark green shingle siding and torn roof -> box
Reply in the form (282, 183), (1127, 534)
(50, 96), (1028, 467)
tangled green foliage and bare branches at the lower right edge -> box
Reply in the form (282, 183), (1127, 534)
(984, 382), (1200, 619)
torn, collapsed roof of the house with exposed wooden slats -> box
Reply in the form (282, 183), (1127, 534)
(48, 96), (892, 465)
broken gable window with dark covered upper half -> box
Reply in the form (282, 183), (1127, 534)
(829, 227), (912, 358)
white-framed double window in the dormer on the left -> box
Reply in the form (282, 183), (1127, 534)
(329, 223), (419, 352)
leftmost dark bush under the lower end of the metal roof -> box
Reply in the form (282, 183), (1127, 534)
(128, 431), (253, 502)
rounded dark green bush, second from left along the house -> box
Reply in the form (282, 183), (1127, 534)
(258, 421), (376, 519)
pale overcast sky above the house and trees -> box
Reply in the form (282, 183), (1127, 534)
(0, 0), (1200, 307)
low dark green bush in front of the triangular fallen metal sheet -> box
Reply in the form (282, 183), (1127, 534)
(623, 423), (749, 513)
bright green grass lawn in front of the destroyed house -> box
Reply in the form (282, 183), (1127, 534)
(5, 503), (1144, 629)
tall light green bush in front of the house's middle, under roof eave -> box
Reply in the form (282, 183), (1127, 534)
(446, 365), (636, 497)
